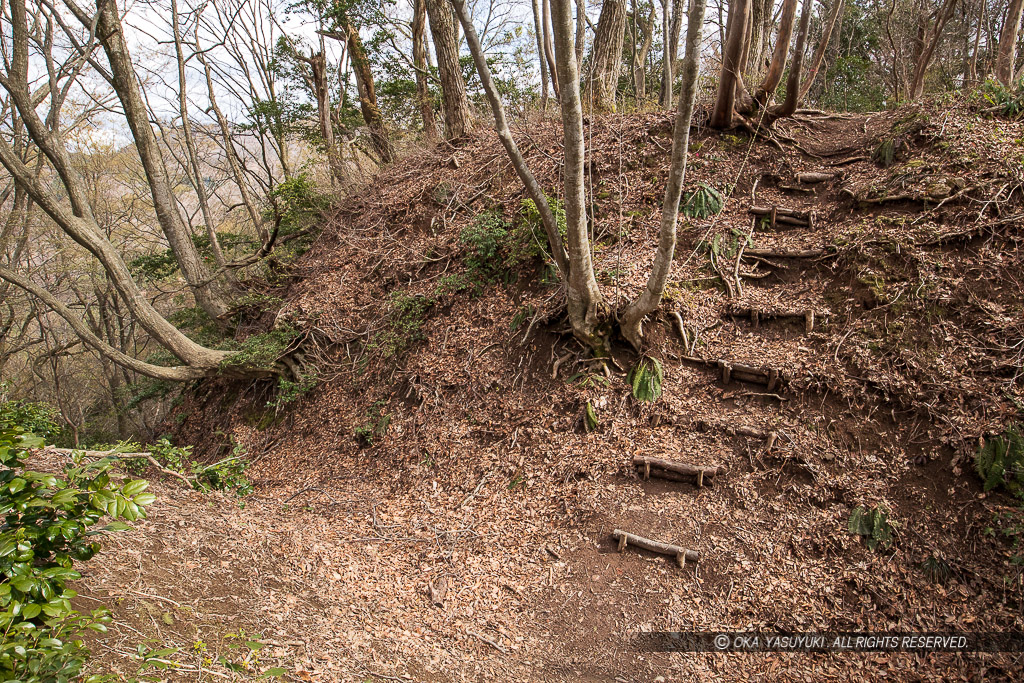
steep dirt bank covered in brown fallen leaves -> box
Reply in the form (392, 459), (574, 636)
(83, 102), (1024, 681)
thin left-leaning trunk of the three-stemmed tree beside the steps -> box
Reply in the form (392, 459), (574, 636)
(452, 0), (569, 279)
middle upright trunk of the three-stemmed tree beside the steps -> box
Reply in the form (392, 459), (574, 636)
(551, 0), (606, 353)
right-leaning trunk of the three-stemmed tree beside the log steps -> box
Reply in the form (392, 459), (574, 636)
(620, 0), (705, 350)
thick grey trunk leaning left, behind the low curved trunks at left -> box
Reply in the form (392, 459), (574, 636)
(96, 0), (230, 319)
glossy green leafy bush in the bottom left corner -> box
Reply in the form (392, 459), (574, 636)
(0, 424), (156, 683)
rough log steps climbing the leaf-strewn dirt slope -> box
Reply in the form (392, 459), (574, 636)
(611, 169), (842, 568)
